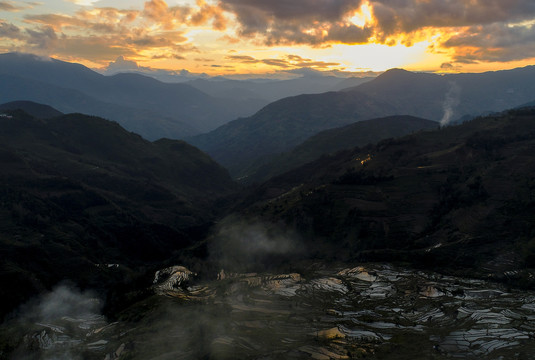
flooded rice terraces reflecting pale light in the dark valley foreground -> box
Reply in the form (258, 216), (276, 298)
(25, 265), (535, 359)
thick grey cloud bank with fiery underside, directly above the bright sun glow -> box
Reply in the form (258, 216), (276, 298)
(220, 0), (535, 46)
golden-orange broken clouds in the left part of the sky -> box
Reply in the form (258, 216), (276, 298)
(11, 0), (203, 63)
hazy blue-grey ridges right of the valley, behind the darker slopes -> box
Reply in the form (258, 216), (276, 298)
(187, 66), (535, 178)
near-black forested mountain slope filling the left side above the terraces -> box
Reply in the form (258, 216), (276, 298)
(0, 110), (235, 314)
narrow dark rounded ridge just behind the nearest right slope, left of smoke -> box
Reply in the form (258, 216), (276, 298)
(248, 115), (438, 182)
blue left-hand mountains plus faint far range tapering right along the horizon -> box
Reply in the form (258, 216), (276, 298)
(0, 53), (372, 140)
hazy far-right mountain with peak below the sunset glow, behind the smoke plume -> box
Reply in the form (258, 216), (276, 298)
(346, 66), (535, 122)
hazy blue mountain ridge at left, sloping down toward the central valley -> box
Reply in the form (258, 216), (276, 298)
(0, 53), (264, 138)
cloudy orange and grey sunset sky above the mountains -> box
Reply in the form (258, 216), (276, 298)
(0, 0), (535, 76)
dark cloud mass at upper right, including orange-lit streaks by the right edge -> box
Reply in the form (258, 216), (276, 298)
(220, 0), (535, 62)
